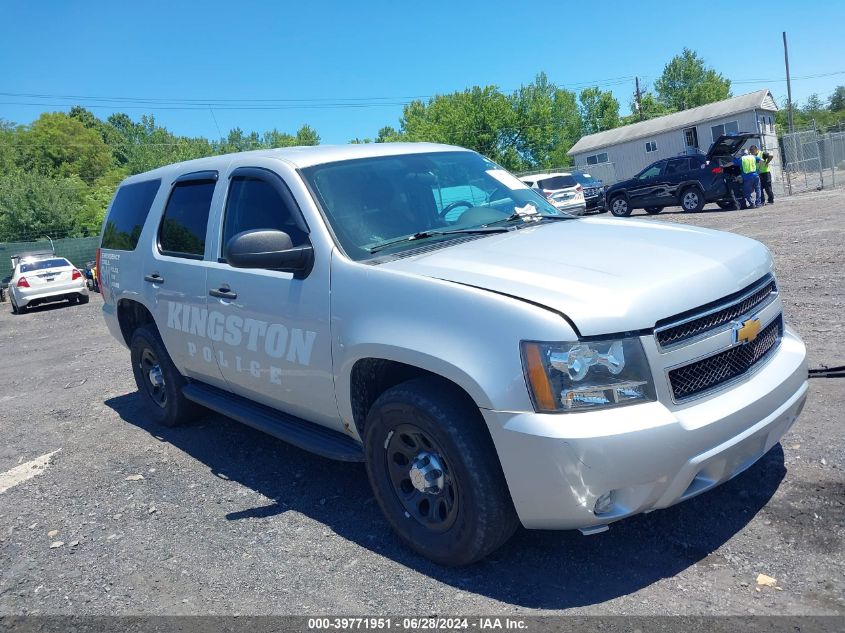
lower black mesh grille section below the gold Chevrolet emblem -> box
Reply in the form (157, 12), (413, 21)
(669, 316), (783, 402)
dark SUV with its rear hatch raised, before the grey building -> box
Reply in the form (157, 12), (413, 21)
(606, 133), (759, 217)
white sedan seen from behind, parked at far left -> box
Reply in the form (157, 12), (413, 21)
(9, 253), (88, 314)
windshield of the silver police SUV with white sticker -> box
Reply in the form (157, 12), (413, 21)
(303, 152), (568, 260)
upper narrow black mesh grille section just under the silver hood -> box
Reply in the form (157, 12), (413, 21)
(654, 275), (777, 348)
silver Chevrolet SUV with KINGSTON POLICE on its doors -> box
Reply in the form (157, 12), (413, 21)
(98, 144), (807, 565)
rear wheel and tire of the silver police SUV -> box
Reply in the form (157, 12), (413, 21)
(129, 325), (199, 426)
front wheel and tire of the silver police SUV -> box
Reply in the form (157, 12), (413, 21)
(364, 377), (519, 566)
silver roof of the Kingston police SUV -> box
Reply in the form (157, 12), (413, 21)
(124, 143), (469, 184)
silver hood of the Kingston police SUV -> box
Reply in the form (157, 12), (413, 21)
(381, 218), (772, 336)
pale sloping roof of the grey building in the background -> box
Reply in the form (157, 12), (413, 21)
(566, 90), (777, 156)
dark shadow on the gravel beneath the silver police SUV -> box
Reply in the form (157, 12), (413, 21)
(106, 393), (786, 609)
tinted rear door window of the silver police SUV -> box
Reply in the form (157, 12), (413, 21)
(158, 176), (217, 259)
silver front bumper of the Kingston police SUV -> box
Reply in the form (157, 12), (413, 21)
(482, 328), (807, 529)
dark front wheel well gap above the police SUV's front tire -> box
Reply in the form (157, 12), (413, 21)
(349, 358), (477, 438)
